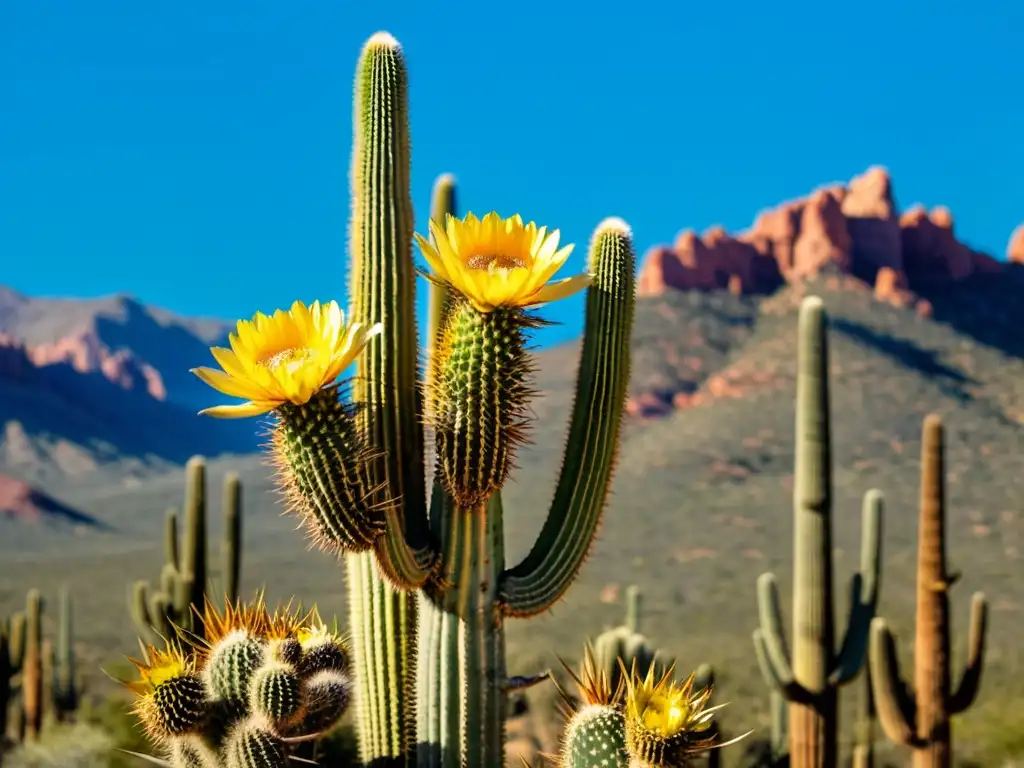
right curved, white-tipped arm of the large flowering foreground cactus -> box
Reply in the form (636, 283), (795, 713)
(502, 219), (635, 616)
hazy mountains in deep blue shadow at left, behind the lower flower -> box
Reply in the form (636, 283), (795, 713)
(0, 288), (257, 482)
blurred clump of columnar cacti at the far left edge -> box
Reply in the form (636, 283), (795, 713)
(0, 587), (82, 758)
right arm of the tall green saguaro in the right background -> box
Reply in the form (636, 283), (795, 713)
(829, 489), (885, 685)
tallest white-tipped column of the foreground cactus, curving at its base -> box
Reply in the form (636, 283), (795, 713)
(350, 33), (436, 589)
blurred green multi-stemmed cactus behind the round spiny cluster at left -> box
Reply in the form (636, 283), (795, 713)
(129, 456), (242, 645)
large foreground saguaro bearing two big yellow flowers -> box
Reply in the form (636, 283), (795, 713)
(188, 33), (635, 766)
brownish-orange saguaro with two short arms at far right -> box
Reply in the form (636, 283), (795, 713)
(870, 415), (988, 768)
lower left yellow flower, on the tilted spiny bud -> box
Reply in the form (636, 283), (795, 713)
(191, 301), (381, 419)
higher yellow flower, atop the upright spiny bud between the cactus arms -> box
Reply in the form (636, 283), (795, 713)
(416, 212), (590, 312)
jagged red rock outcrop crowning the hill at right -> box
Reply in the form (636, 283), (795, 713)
(638, 167), (1024, 305)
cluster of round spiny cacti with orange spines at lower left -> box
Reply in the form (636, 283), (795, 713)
(120, 596), (351, 768)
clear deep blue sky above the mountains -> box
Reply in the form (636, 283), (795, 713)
(0, 0), (1024, 348)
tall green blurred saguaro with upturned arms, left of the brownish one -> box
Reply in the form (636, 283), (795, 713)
(754, 296), (883, 768)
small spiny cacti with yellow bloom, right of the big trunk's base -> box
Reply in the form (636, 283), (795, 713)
(559, 645), (748, 768)
